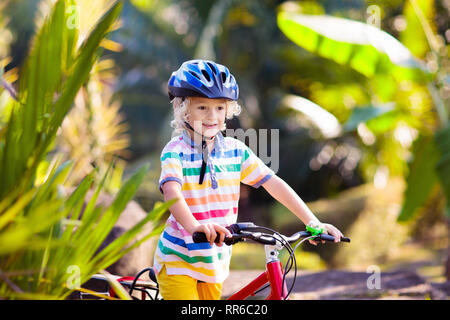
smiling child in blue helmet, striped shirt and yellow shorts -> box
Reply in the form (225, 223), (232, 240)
(154, 60), (343, 300)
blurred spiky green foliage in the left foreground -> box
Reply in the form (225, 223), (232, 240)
(0, 0), (173, 299)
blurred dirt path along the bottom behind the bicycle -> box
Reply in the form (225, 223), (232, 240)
(223, 270), (450, 300)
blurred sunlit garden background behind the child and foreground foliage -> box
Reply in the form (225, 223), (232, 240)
(0, 0), (450, 300)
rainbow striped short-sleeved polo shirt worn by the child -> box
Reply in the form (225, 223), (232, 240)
(154, 131), (274, 283)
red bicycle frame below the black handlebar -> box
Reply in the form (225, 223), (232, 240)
(227, 245), (288, 300)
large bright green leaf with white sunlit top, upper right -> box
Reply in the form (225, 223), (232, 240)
(277, 11), (429, 80)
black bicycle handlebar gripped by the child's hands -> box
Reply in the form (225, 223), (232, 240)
(192, 222), (350, 245)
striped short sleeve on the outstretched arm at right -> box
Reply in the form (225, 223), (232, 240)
(241, 143), (275, 188)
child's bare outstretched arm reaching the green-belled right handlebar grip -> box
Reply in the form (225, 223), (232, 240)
(262, 175), (344, 244)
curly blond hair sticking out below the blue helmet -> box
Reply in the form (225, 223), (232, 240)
(170, 97), (241, 137)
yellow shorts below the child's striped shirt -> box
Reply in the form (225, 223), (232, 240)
(157, 266), (222, 300)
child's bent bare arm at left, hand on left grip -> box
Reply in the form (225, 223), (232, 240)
(161, 181), (231, 246)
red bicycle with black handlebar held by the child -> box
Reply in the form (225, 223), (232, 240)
(81, 222), (350, 300)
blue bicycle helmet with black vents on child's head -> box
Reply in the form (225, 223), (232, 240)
(168, 60), (239, 100)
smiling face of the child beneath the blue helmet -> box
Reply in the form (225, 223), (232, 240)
(188, 97), (227, 137)
